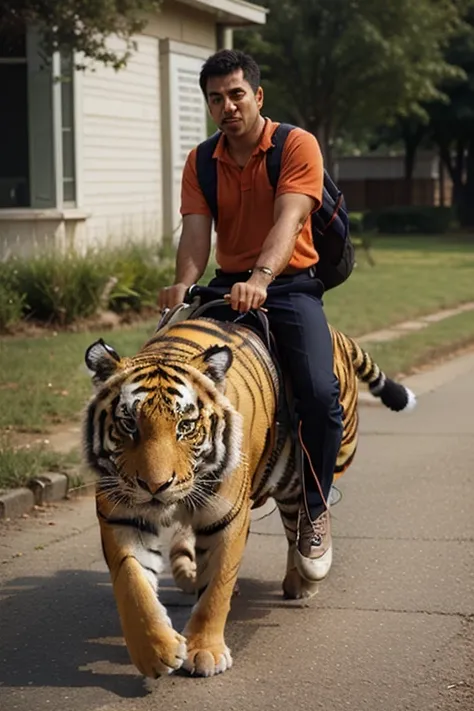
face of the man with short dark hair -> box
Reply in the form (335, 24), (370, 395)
(207, 69), (263, 137)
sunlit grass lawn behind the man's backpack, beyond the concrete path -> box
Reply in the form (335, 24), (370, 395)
(325, 235), (474, 336)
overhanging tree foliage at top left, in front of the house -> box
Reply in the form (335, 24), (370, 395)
(0, 0), (161, 69)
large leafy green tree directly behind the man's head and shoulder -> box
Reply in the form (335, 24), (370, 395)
(237, 0), (459, 171)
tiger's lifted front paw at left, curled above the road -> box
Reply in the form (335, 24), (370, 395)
(127, 627), (186, 679)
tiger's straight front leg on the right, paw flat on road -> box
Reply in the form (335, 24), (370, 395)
(183, 502), (250, 676)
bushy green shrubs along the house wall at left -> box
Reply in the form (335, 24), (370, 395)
(0, 244), (175, 330)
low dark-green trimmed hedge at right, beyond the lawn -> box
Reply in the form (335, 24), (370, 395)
(365, 207), (454, 234)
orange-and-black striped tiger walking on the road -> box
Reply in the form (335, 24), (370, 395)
(83, 317), (415, 678)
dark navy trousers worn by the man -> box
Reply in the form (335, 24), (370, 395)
(206, 272), (342, 520)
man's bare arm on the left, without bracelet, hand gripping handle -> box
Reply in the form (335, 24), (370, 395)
(158, 215), (212, 309)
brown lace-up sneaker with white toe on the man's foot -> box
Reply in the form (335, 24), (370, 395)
(295, 506), (332, 582)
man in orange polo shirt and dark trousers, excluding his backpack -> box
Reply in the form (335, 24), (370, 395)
(159, 50), (342, 580)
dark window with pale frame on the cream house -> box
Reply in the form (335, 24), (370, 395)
(0, 28), (76, 209)
